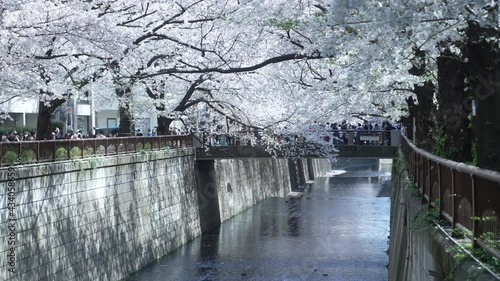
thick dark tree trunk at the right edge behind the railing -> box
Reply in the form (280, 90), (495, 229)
(465, 22), (500, 171)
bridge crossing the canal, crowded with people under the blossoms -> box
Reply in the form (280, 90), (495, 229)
(193, 130), (401, 160)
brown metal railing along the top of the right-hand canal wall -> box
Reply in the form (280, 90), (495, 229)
(401, 137), (500, 258)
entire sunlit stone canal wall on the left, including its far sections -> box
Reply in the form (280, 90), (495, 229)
(0, 149), (330, 281)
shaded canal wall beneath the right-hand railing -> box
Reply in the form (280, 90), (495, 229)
(388, 153), (499, 281)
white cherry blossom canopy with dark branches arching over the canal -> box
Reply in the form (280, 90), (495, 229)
(0, 0), (498, 166)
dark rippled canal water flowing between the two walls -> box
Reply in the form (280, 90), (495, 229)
(126, 159), (391, 281)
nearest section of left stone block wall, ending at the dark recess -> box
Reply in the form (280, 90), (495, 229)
(0, 149), (200, 281)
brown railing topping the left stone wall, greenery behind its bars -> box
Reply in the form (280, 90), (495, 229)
(0, 135), (193, 167)
